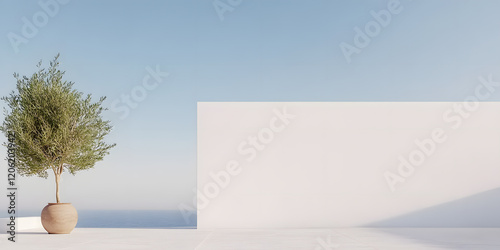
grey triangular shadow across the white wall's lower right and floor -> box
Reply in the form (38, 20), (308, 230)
(365, 188), (500, 250)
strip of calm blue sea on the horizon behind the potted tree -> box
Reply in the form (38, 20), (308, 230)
(0, 210), (196, 229)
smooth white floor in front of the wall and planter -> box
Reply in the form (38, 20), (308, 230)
(0, 228), (500, 250)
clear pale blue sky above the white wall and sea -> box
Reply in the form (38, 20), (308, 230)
(0, 0), (500, 213)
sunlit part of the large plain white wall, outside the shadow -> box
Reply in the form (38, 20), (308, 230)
(198, 102), (500, 228)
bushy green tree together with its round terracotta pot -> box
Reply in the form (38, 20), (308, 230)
(0, 55), (115, 234)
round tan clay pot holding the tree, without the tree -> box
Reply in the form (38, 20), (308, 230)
(42, 203), (78, 234)
